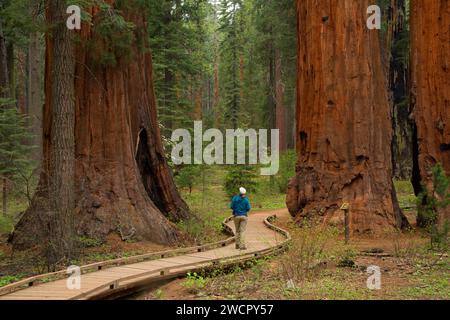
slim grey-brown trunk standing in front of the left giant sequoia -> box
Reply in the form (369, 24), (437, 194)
(46, 0), (75, 265)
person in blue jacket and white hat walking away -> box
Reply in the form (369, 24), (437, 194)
(230, 187), (251, 250)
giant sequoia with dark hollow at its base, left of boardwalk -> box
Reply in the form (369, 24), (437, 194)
(11, 1), (189, 248)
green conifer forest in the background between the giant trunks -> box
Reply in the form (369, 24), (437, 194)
(0, 0), (412, 215)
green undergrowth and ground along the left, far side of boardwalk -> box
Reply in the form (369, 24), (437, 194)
(0, 167), (285, 287)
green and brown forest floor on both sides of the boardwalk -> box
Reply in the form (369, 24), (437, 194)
(0, 168), (450, 299)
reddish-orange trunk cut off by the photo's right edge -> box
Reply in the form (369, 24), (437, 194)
(410, 0), (450, 223)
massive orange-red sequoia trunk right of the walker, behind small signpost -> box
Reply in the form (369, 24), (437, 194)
(287, 0), (407, 233)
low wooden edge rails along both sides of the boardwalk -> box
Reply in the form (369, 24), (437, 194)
(0, 215), (291, 299)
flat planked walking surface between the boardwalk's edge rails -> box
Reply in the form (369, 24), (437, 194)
(0, 213), (286, 300)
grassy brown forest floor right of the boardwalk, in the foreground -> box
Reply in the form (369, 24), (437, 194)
(127, 210), (450, 300)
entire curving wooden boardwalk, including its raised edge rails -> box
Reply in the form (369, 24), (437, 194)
(0, 210), (290, 300)
